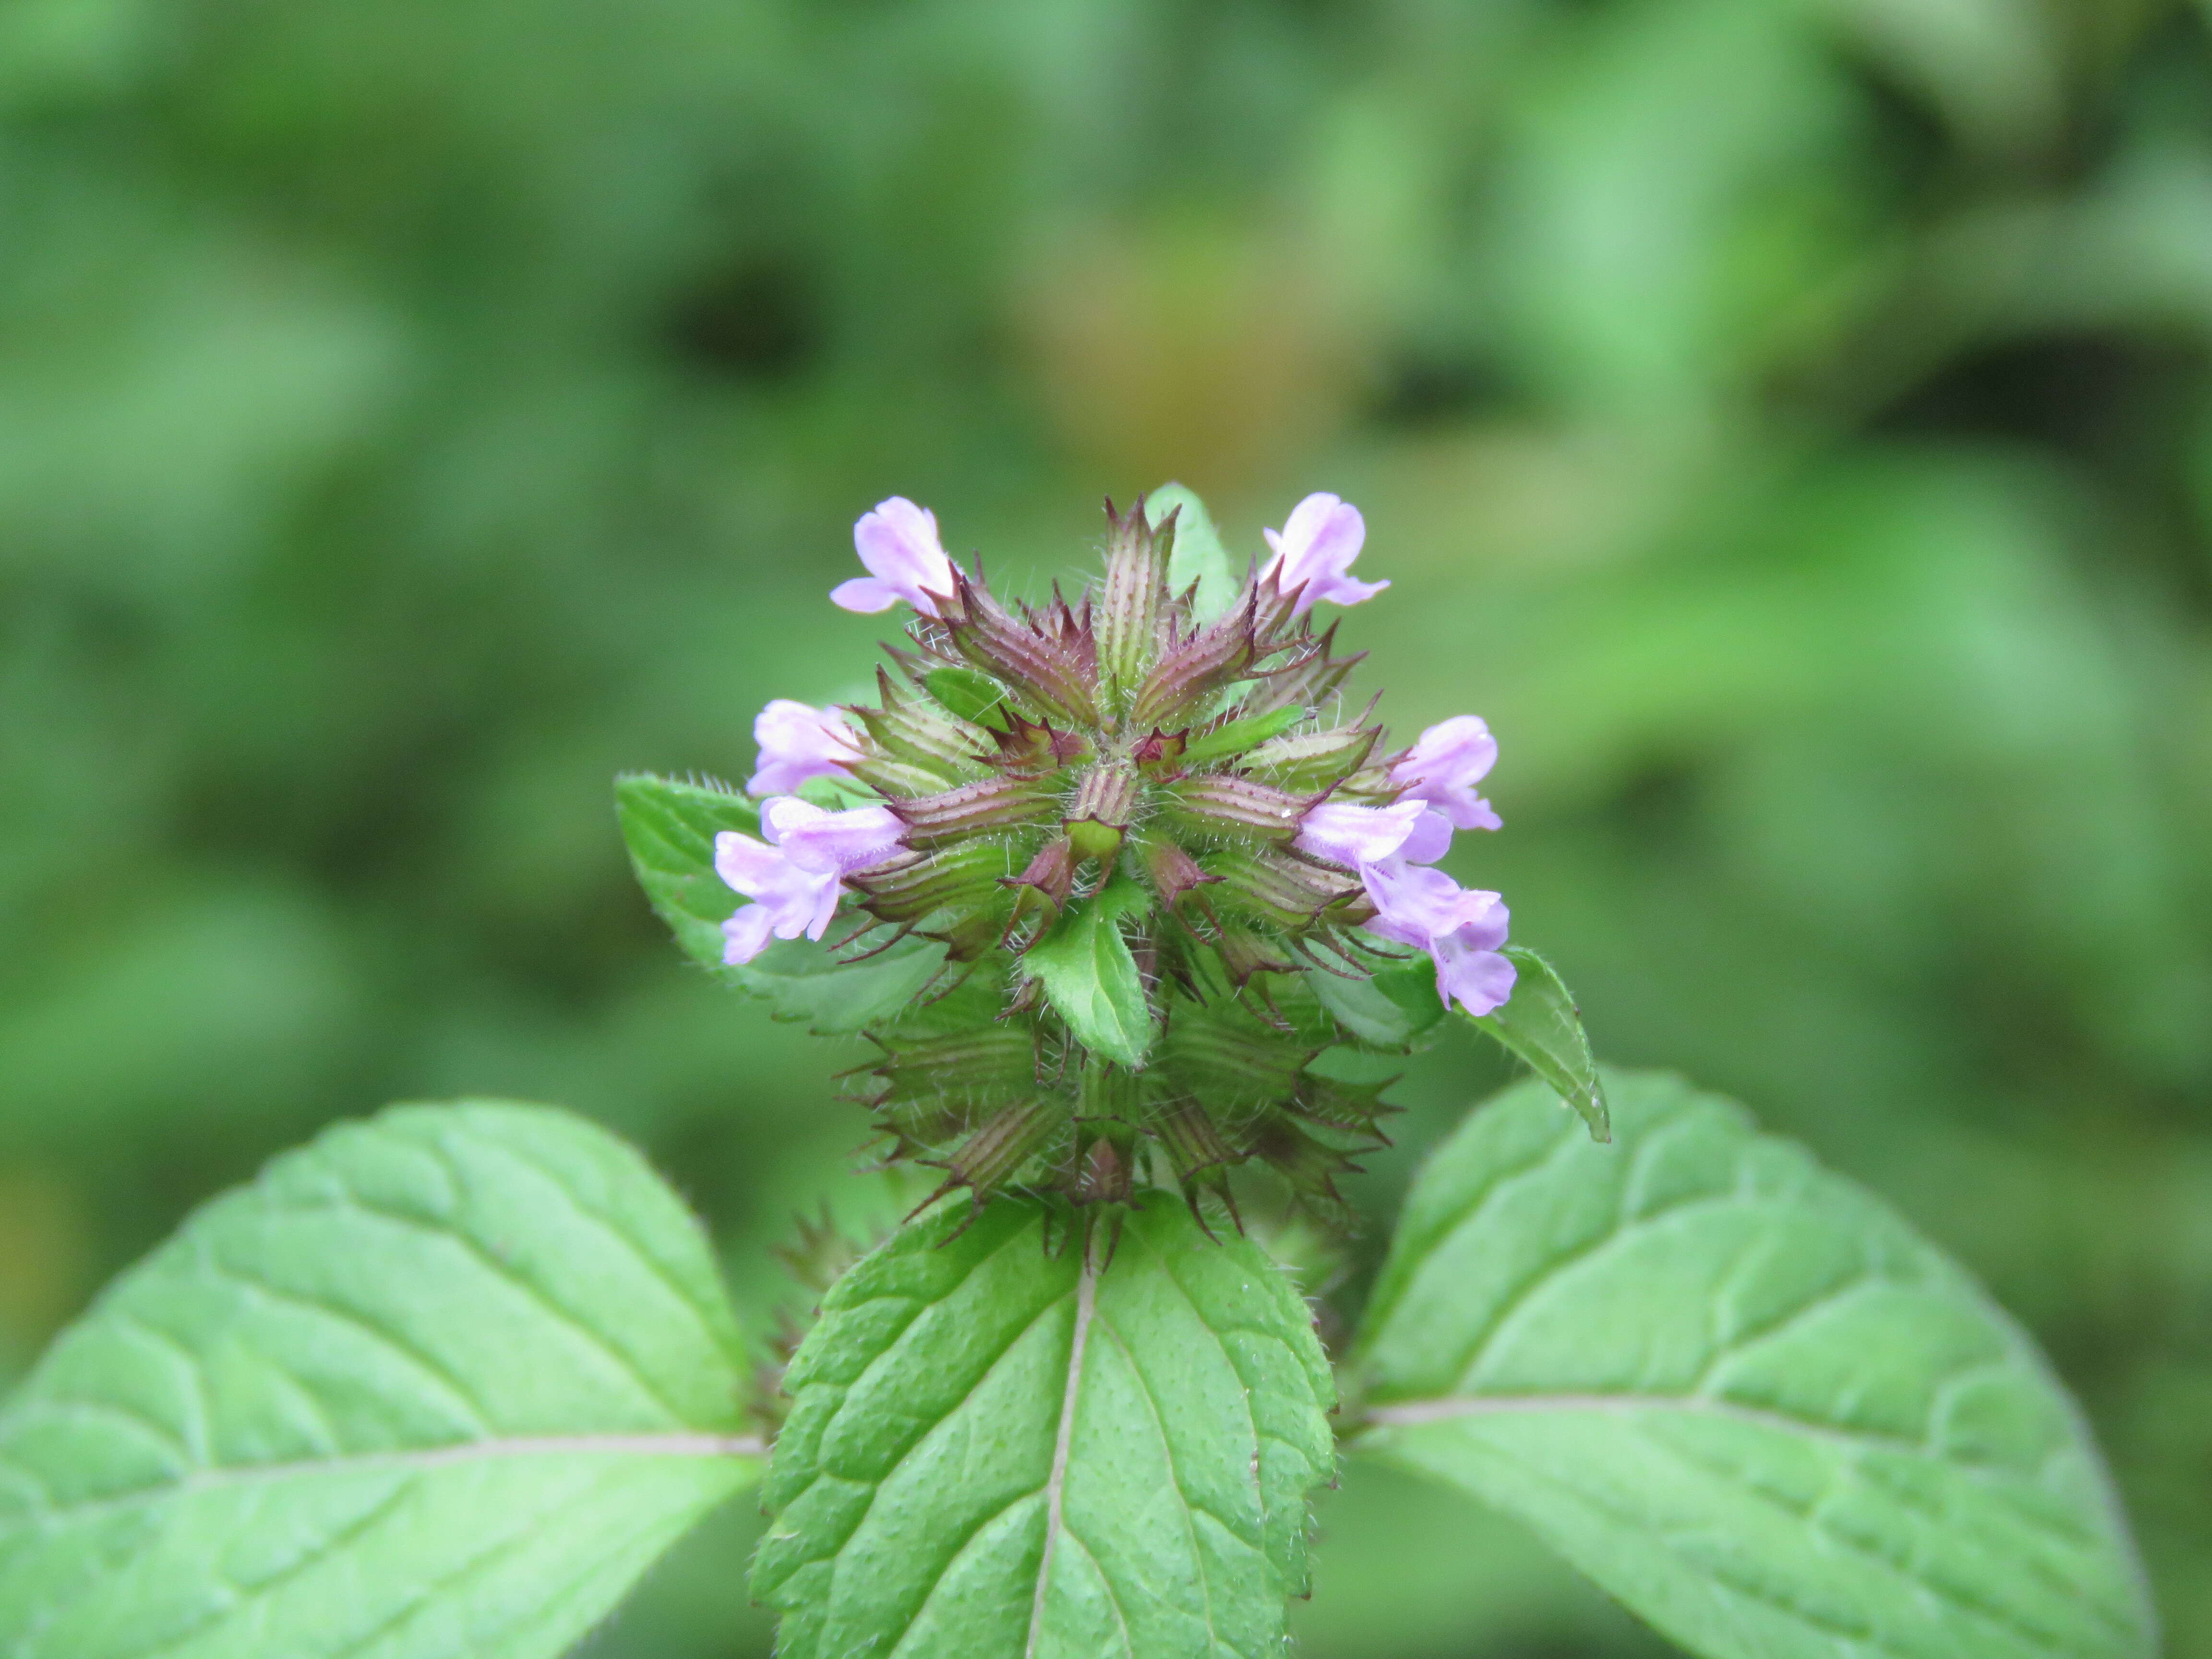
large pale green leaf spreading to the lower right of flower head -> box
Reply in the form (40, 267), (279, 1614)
(1354, 1073), (2152, 1659)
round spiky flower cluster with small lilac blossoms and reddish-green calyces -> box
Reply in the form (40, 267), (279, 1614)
(714, 495), (1513, 1201)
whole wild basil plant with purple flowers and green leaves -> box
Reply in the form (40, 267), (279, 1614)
(0, 487), (2154, 1659)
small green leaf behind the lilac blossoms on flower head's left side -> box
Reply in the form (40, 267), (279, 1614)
(615, 774), (945, 1035)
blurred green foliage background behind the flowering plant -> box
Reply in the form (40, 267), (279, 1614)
(0, 0), (2212, 1659)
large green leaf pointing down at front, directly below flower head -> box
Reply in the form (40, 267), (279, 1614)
(752, 1194), (1334, 1659)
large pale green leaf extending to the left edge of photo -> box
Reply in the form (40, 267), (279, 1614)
(0, 1104), (761, 1659)
